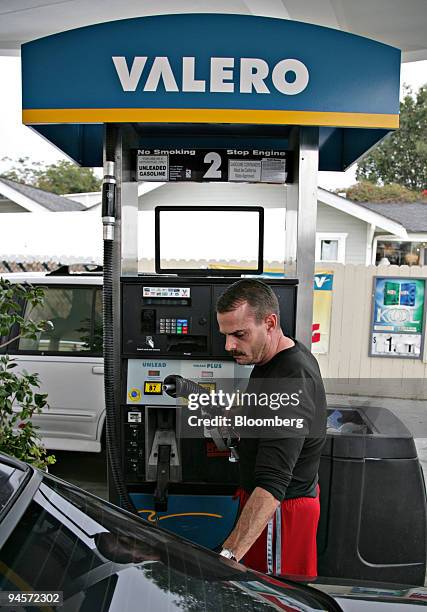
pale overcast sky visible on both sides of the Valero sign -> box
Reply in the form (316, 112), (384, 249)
(0, 57), (427, 189)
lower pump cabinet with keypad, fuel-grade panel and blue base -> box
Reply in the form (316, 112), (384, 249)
(120, 266), (297, 548)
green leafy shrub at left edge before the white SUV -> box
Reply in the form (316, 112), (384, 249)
(0, 278), (55, 469)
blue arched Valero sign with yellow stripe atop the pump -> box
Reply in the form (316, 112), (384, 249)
(22, 13), (400, 170)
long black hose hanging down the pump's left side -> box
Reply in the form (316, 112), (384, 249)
(102, 125), (138, 514)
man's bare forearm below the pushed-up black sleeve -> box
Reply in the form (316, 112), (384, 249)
(223, 487), (280, 561)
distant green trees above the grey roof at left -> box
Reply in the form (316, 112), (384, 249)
(1, 157), (102, 195)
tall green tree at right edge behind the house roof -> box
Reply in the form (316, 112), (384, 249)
(356, 85), (427, 191)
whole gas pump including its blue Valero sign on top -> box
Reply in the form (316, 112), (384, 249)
(22, 9), (406, 573)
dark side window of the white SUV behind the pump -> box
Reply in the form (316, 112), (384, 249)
(17, 286), (102, 355)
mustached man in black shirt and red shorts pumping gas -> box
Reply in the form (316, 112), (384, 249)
(216, 279), (327, 580)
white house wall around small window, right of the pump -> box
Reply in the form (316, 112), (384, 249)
(317, 202), (367, 264)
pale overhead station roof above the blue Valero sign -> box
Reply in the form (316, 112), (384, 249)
(0, 0), (427, 62)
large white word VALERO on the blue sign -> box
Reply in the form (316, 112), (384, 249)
(112, 56), (309, 96)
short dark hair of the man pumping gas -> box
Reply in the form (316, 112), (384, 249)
(216, 278), (280, 323)
